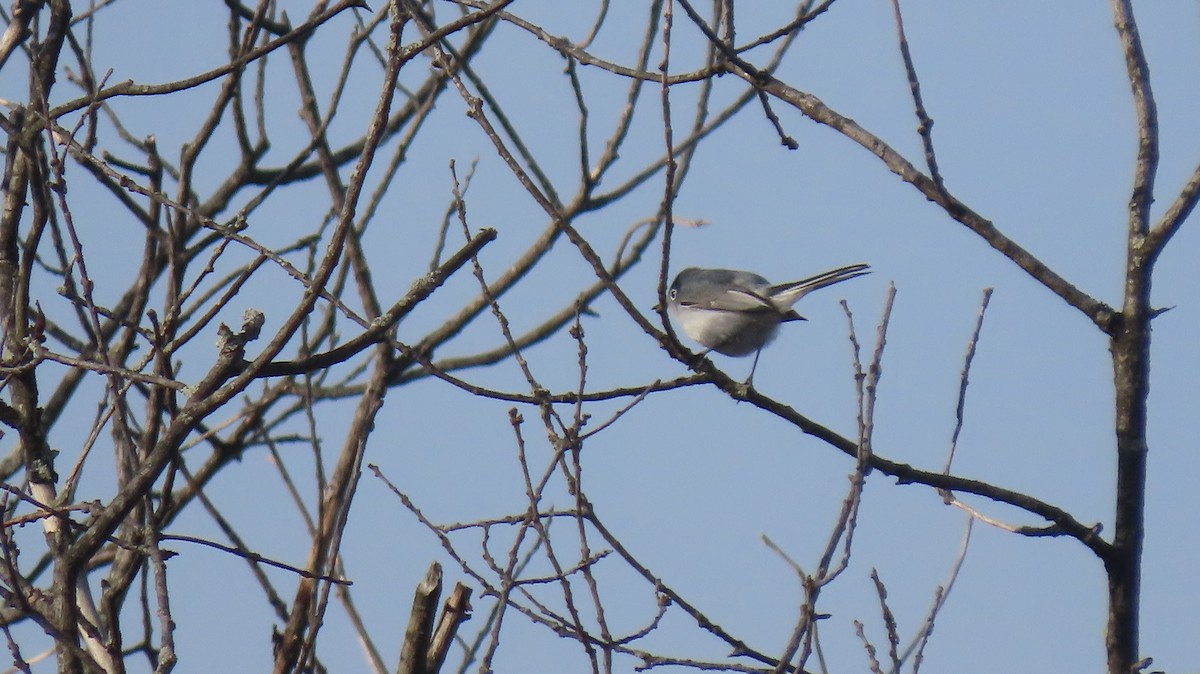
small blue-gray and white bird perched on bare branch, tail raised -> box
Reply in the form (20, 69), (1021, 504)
(667, 264), (870, 383)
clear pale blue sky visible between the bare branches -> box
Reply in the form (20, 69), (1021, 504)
(0, 0), (1200, 674)
